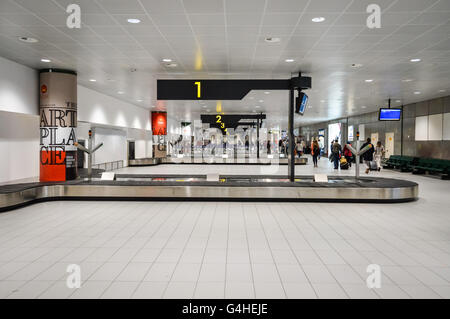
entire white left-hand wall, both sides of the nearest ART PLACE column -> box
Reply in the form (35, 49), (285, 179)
(0, 57), (152, 182)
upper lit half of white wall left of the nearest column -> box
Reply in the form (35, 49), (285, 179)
(0, 57), (39, 115)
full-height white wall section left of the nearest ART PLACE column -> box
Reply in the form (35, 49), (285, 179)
(0, 57), (39, 182)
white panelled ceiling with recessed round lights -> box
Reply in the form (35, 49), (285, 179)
(0, 0), (450, 127)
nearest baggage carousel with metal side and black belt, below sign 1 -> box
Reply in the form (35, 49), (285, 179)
(0, 174), (418, 212)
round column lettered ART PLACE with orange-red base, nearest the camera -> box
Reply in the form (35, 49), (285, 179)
(39, 69), (78, 182)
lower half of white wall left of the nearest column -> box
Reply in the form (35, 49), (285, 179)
(0, 111), (39, 183)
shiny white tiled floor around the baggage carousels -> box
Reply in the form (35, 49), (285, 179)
(0, 161), (450, 298)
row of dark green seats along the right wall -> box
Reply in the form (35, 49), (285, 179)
(383, 155), (450, 179)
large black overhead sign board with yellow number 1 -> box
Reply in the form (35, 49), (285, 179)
(157, 77), (311, 100)
